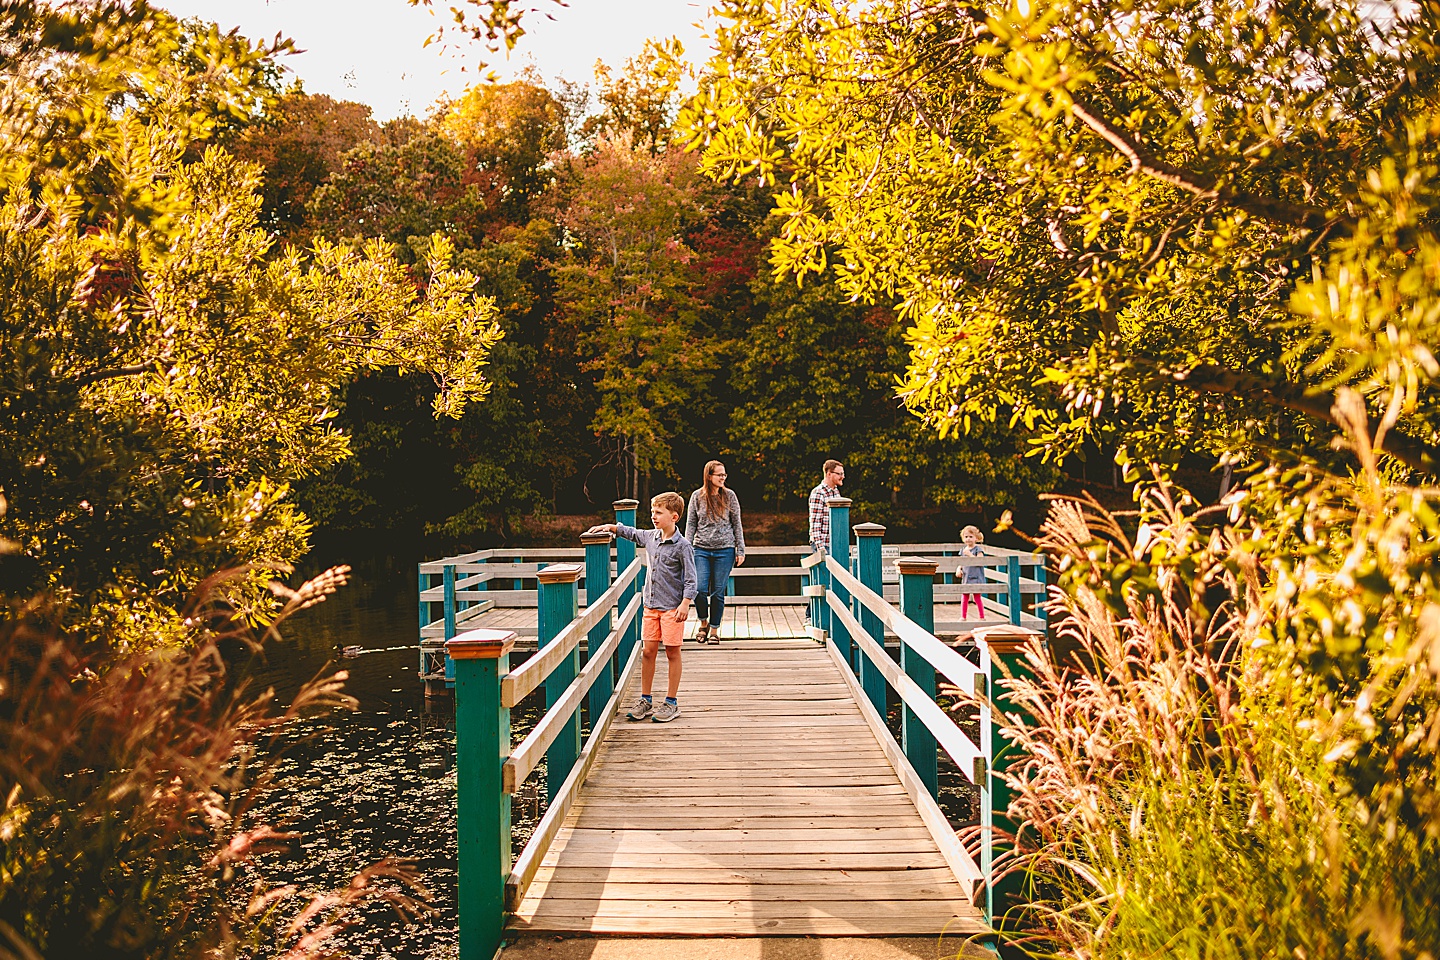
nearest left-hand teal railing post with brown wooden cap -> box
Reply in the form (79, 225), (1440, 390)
(445, 630), (516, 960)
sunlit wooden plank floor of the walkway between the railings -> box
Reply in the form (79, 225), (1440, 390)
(513, 639), (982, 936)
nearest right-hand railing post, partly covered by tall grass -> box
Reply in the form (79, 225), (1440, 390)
(975, 625), (1035, 930)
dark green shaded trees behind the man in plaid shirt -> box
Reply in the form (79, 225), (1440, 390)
(727, 271), (1060, 522)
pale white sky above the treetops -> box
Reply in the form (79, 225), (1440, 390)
(160, 0), (710, 121)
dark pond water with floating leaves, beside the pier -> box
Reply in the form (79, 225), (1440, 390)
(244, 560), (978, 960)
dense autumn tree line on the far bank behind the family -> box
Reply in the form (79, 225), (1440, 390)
(222, 56), (1057, 543)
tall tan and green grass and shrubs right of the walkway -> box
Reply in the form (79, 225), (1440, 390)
(979, 397), (1440, 960)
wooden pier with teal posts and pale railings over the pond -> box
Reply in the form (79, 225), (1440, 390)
(434, 498), (1045, 960)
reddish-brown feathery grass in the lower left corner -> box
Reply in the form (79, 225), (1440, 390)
(0, 564), (422, 960)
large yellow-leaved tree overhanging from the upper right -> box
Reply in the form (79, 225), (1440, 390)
(688, 3), (1431, 469)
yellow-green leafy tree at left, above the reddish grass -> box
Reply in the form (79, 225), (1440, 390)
(0, 3), (500, 643)
